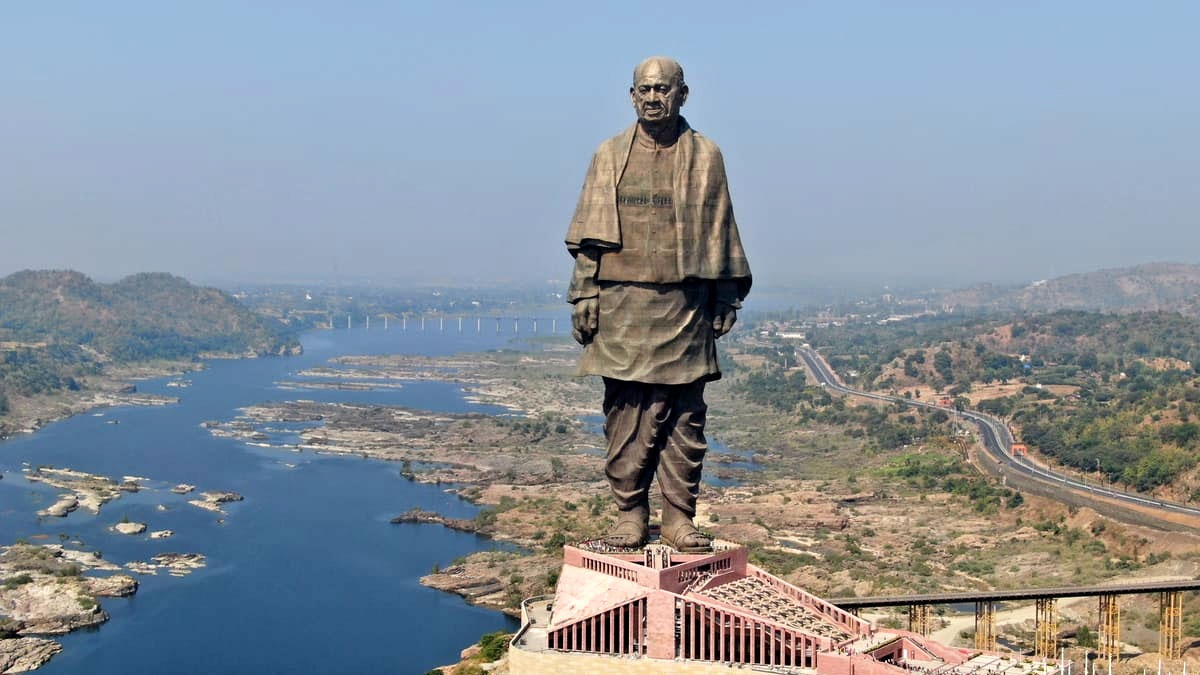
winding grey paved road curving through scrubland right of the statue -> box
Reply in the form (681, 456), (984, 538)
(796, 345), (1200, 533)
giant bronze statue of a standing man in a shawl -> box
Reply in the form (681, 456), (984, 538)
(566, 56), (750, 552)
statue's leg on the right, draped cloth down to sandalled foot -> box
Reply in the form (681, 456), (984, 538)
(658, 382), (713, 552)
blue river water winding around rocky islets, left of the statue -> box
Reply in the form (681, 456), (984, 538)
(0, 330), (540, 675)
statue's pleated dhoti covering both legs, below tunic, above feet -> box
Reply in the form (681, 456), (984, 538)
(604, 377), (708, 530)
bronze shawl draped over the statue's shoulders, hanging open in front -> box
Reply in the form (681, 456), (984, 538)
(566, 118), (751, 298)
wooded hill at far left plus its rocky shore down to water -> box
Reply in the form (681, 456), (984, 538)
(0, 270), (300, 420)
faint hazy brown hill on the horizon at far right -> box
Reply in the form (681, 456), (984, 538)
(943, 263), (1200, 316)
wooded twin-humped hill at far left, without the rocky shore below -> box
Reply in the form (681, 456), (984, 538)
(0, 270), (296, 362)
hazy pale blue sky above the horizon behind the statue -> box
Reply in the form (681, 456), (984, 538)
(0, 0), (1200, 286)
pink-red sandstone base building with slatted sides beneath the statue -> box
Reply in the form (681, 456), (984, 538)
(509, 545), (1060, 675)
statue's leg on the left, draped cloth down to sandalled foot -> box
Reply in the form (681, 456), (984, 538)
(604, 377), (666, 548)
